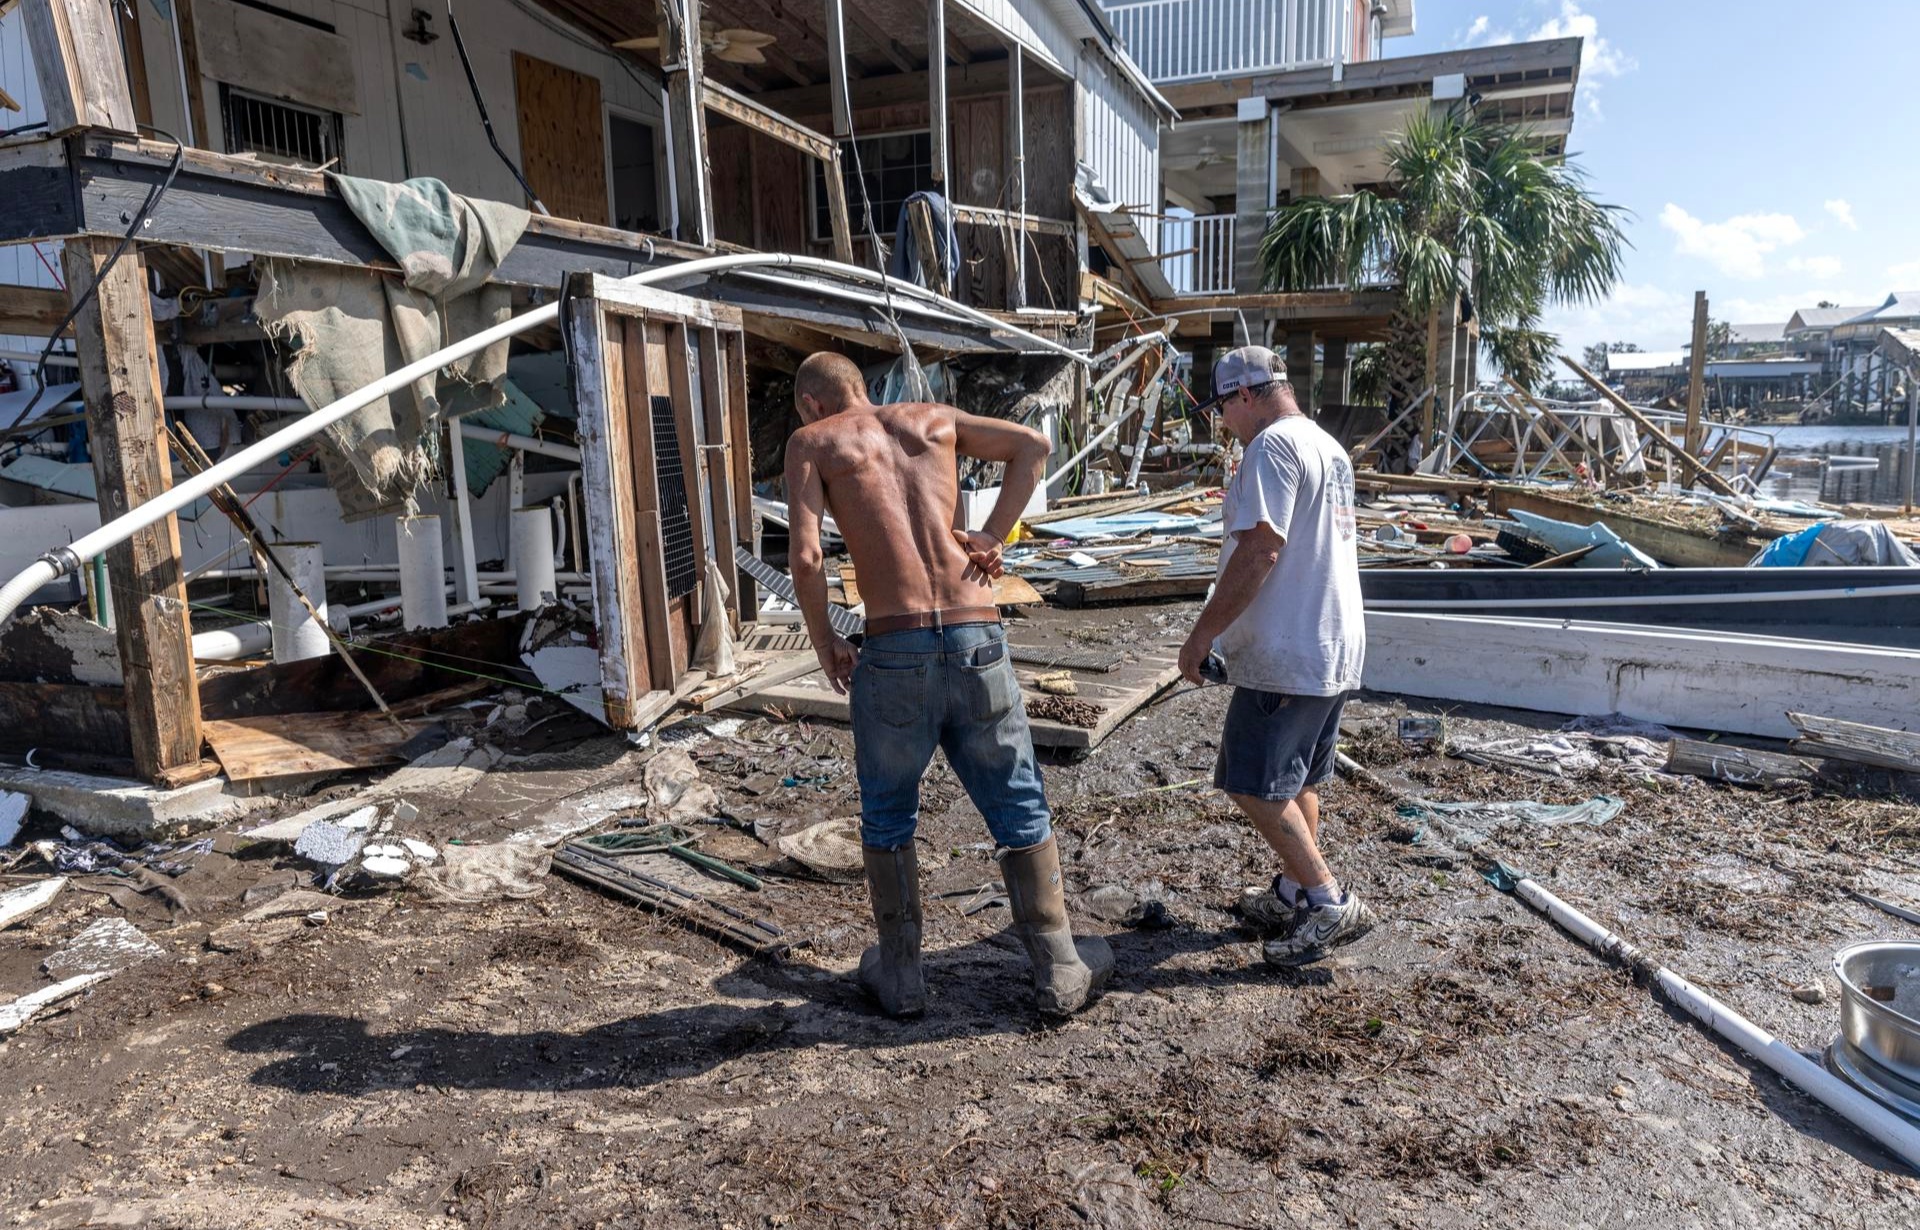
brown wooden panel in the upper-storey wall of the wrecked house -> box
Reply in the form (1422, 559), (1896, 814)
(513, 52), (611, 226)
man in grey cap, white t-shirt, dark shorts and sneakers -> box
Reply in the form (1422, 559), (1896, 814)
(1181, 345), (1375, 965)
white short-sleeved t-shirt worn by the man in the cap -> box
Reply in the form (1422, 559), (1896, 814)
(1213, 414), (1367, 697)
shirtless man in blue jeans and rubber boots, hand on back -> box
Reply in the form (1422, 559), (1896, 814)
(787, 353), (1114, 1017)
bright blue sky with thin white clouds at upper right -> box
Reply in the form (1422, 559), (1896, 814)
(1386, 0), (1920, 353)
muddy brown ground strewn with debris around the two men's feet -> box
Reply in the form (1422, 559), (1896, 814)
(0, 606), (1920, 1230)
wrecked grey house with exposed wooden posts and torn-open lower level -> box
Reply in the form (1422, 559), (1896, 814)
(0, 0), (1173, 785)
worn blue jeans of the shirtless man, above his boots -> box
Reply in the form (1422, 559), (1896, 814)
(852, 624), (1054, 850)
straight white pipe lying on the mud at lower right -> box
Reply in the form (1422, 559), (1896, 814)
(1515, 879), (1920, 1171)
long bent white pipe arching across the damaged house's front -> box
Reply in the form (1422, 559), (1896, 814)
(0, 251), (1091, 626)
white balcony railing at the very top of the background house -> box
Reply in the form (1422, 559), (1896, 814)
(1102, 0), (1354, 84)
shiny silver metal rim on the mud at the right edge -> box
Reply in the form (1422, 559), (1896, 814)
(1828, 942), (1920, 1119)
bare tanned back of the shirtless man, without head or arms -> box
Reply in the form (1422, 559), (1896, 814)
(787, 401), (993, 618)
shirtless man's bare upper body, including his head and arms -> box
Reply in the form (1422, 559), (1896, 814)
(787, 353), (1048, 691)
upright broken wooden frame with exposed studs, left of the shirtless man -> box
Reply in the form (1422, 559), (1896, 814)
(563, 274), (756, 729)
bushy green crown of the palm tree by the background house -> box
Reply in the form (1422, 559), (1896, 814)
(1260, 113), (1626, 413)
